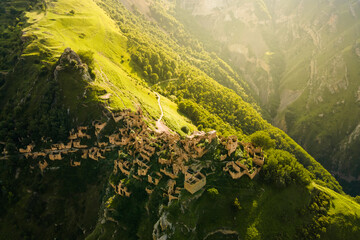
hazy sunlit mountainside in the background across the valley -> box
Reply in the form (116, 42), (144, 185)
(165, 0), (360, 195)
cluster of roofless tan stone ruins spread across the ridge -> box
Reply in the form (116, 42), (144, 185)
(19, 110), (264, 201)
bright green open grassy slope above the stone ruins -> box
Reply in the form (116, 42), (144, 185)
(19, 1), (195, 132)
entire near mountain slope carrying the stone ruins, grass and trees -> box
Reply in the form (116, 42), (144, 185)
(0, 0), (360, 239)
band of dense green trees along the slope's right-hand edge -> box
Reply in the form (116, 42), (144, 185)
(99, 0), (341, 191)
